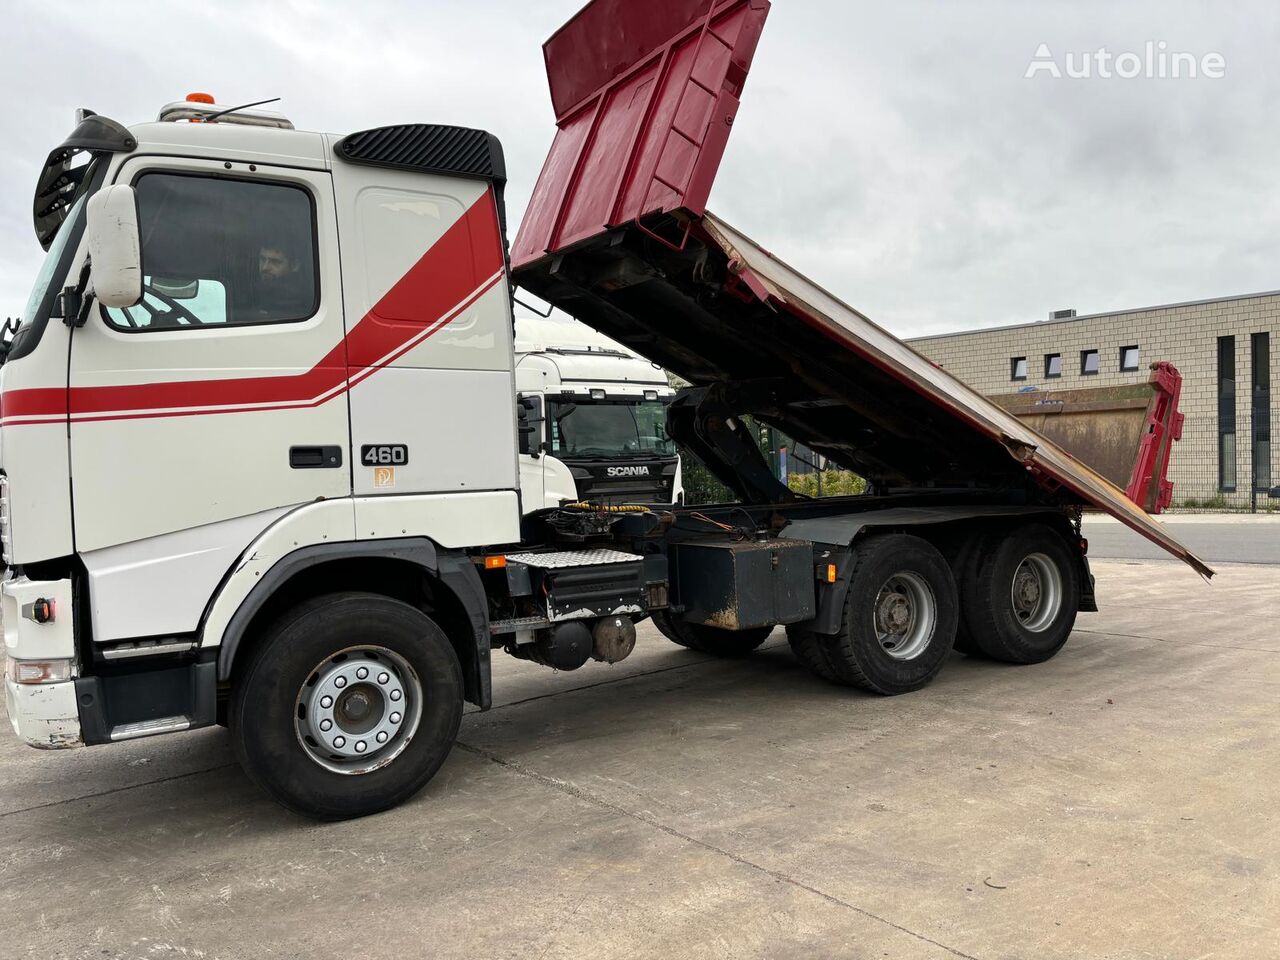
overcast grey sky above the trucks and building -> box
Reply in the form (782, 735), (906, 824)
(0, 0), (1280, 335)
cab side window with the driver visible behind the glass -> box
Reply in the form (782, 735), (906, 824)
(102, 173), (320, 330)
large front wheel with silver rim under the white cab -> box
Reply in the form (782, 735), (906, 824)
(229, 593), (462, 820)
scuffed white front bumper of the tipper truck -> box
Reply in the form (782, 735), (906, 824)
(0, 577), (84, 750)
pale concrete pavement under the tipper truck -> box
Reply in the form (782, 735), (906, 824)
(0, 561), (1280, 960)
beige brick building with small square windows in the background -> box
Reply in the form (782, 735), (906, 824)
(911, 292), (1280, 511)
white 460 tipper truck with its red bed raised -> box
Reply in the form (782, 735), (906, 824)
(0, 0), (1211, 818)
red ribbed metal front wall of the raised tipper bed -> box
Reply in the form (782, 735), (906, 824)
(511, 0), (769, 269)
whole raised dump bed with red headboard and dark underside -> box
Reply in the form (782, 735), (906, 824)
(512, 0), (1212, 576)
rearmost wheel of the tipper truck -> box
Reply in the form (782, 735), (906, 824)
(964, 524), (1080, 663)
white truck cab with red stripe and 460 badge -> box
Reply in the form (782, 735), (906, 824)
(0, 96), (520, 798)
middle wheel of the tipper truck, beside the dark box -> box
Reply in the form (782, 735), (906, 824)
(792, 534), (957, 695)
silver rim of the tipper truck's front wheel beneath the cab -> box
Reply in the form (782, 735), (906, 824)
(293, 646), (422, 774)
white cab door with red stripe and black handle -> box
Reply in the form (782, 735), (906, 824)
(69, 156), (351, 556)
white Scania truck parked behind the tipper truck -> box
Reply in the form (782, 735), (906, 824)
(516, 316), (684, 513)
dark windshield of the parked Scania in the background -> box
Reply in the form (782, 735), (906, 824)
(547, 397), (676, 460)
